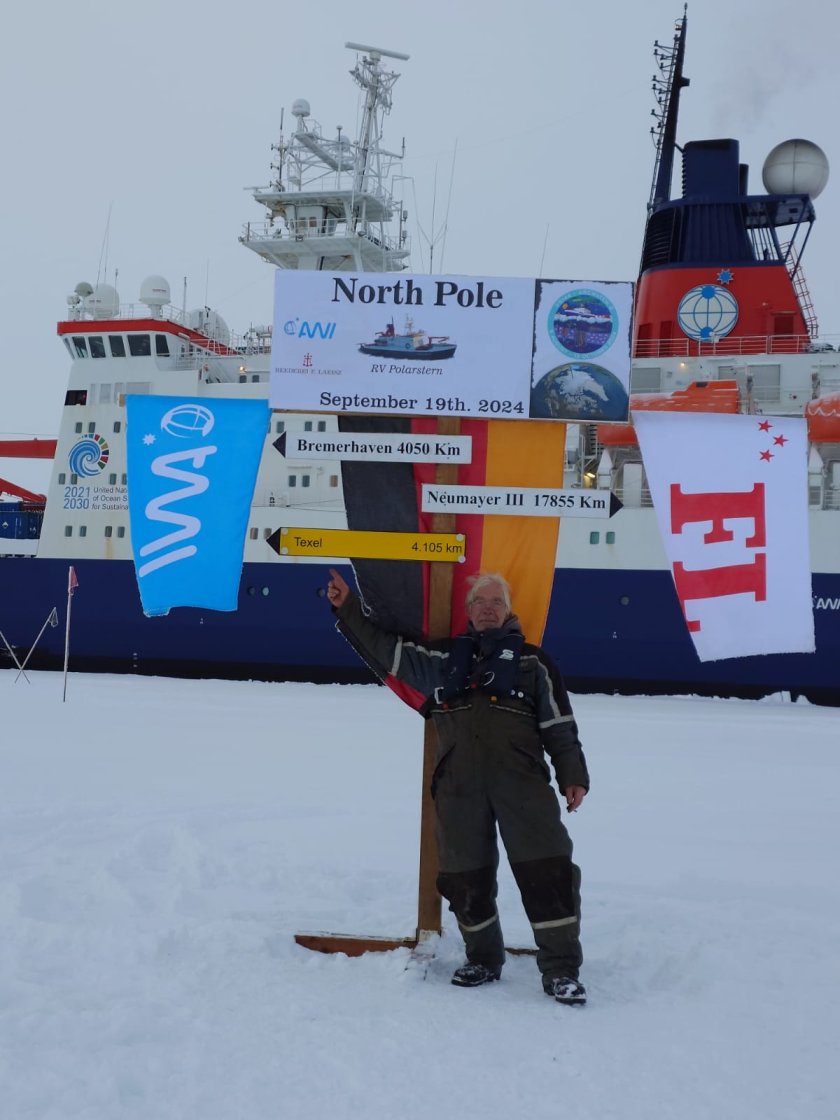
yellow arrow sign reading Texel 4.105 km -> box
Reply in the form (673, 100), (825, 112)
(268, 528), (466, 563)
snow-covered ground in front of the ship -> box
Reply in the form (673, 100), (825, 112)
(0, 671), (840, 1120)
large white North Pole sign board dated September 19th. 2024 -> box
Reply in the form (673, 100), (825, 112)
(270, 270), (633, 422)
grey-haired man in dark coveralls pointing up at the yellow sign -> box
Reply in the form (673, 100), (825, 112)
(327, 569), (589, 1004)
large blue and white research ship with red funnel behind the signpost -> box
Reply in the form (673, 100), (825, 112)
(0, 24), (840, 703)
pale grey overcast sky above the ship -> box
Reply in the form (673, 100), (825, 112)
(0, 0), (840, 435)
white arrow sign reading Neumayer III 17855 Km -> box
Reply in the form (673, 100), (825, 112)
(421, 483), (622, 517)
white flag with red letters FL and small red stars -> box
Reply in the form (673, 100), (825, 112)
(633, 410), (814, 661)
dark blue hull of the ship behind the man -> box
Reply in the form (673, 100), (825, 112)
(0, 558), (840, 704)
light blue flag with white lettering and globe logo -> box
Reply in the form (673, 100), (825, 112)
(125, 395), (270, 616)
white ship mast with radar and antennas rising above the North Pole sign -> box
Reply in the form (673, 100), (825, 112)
(240, 43), (410, 272)
